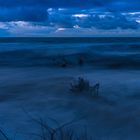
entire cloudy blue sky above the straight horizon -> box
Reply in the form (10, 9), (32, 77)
(0, 0), (140, 37)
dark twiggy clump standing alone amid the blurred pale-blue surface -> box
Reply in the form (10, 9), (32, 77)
(70, 77), (100, 97)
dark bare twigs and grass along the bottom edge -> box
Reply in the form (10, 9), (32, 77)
(0, 119), (93, 140)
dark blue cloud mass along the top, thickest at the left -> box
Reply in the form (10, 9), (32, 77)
(0, 0), (140, 21)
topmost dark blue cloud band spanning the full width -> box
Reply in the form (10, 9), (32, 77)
(0, 0), (140, 10)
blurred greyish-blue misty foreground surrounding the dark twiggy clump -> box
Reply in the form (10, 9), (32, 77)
(0, 68), (140, 140)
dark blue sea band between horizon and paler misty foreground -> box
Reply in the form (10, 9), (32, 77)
(0, 38), (140, 69)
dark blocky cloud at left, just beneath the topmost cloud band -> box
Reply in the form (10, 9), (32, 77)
(0, 7), (47, 22)
